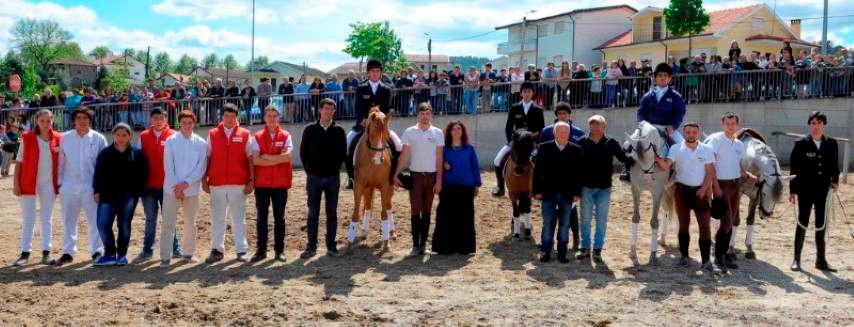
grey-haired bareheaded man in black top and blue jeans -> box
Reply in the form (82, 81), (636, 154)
(533, 122), (585, 263)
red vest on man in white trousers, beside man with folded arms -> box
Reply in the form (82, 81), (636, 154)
(208, 123), (251, 186)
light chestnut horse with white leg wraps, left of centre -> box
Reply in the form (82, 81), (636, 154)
(347, 107), (394, 255)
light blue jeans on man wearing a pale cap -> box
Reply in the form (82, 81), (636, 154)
(580, 187), (611, 250)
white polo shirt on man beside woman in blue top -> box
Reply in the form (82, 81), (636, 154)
(402, 125), (445, 173)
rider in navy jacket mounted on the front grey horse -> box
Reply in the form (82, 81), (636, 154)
(620, 63), (685, 181)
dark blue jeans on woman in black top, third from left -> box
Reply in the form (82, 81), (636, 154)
(98, 196), (139, 257)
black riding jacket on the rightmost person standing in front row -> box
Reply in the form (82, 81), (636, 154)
(789, 136), (839, 194)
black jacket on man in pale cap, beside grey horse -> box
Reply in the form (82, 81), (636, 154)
(578, 136), (634, 188)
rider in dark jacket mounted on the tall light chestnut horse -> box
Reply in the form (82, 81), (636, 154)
(345, 59), (403, 189)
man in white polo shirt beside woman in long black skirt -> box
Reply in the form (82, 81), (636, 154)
(394, 102), (445, 257)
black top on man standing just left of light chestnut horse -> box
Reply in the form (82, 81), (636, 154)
(299, 122), (347, 177)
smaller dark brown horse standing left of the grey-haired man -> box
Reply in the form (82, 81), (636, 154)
(504, 130), (537, 240)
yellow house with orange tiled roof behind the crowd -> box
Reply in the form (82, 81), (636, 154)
(595, 4), (819, 63)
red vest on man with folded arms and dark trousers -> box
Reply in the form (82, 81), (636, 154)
(255, 127), (292, 189)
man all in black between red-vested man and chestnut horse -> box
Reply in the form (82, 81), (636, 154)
(299, 98), (347, 259)
